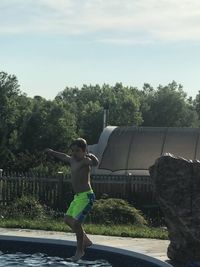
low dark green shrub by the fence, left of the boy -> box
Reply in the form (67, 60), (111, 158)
(5, 196), (46, 219)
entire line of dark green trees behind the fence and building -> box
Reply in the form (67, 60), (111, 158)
(0, 71), (200, 172)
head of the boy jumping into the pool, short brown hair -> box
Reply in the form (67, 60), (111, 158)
(70, 138), (87, 160)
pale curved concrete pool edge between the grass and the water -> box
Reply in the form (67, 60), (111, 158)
(0, 228), (171, 266)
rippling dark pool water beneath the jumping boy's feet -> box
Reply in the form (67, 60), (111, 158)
(0, 251), (112, 267)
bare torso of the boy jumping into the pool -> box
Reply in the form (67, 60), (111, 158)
(70, 157), (92, 194)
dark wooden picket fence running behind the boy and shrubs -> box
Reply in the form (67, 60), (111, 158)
(0, 174), (157, 211)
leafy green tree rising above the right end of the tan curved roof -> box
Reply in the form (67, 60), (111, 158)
(141, 81), (198, 127)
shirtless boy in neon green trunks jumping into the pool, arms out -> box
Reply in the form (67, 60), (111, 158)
(46, 138), (99, 261)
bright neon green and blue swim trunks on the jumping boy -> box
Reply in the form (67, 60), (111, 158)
(66, 190), (95, 222)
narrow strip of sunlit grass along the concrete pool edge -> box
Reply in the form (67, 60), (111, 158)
(0, 218), (168, 239)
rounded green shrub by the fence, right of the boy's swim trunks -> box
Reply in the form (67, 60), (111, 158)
(90, 198), (147, 226)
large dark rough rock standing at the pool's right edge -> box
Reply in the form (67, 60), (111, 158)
(149, 154), (200, 263)
